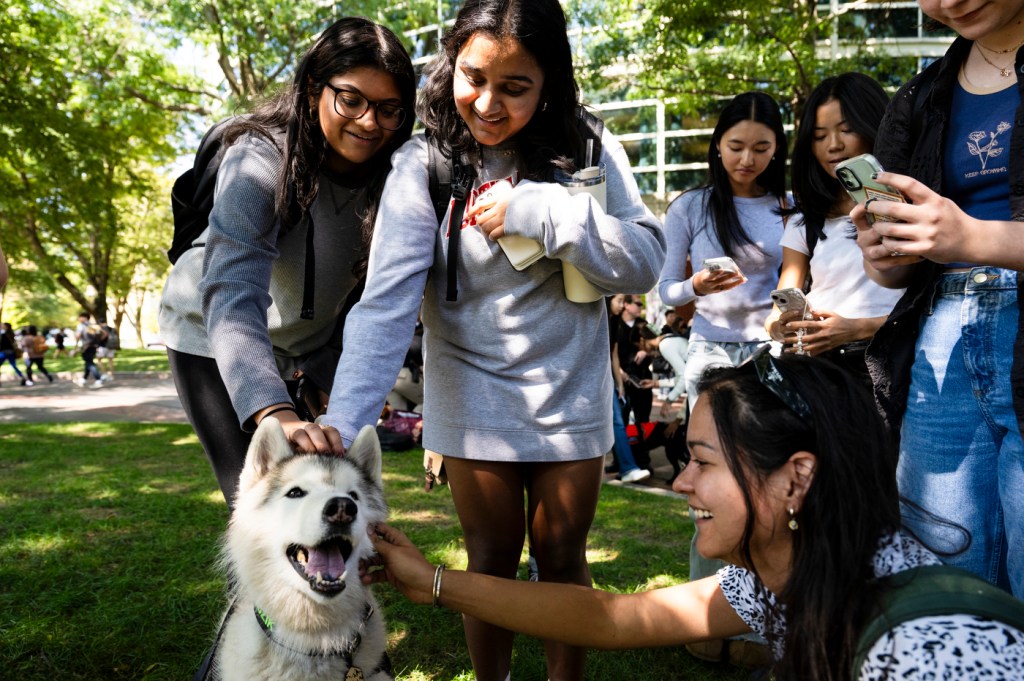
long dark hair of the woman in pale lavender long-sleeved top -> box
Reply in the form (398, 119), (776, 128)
(703, 92), (786, 257)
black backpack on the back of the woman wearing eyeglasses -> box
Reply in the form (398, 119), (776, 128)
(167, 116), (237, 264)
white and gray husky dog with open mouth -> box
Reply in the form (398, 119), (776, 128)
(213, 417), (392, 681)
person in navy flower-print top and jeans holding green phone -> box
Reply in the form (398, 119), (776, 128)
(851, 0), (1024, 597)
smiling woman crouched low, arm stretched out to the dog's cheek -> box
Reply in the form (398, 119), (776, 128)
(362, 346), (1024, 679)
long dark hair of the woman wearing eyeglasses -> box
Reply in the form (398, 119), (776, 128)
(225, 16), (416, 269)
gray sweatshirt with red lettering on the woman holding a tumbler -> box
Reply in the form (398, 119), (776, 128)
(326, 133), (665, 462)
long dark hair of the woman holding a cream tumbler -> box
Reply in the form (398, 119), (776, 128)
(418, 0), (583, 179)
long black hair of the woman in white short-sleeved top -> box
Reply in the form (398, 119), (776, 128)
(791, 72), (889, 239)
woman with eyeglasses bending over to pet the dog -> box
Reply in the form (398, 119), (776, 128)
(160, 17), (416, 508)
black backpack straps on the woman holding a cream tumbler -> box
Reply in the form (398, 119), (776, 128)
(425, 108), (604, 301)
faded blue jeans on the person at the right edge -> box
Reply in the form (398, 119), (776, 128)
(897, 267), (1024, 598)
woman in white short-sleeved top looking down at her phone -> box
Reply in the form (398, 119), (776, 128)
(765, 73), (902, 386)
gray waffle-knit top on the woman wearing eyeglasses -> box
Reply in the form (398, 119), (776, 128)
(160, 134), (366, 427)
